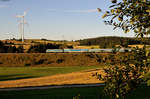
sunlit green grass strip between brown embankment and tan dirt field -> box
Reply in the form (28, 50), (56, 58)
(0, 66), (102, 81)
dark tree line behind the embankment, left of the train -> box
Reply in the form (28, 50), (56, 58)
(0, 41), (73, 53)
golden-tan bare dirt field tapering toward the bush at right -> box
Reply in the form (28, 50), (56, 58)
(0, 69), (103, 88)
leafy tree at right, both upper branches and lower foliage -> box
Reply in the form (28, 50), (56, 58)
(97, 0), (150, 99)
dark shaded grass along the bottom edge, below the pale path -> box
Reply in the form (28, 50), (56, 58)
(0, 85), (150, 99)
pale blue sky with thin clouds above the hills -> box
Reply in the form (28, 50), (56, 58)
(0, 0), (134, 40)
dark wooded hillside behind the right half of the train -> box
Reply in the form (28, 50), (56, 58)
(78, 36), (150, 48)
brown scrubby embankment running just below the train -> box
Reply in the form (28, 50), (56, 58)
(0, 53), (127, 67)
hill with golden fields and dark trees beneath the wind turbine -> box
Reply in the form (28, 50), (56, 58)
(0, 39), (79, 53)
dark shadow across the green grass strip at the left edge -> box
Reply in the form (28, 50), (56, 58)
(0, 74), (35, 81)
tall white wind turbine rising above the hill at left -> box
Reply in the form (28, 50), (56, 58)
(16, 11), (27, 42)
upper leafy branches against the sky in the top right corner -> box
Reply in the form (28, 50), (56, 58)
(99, 0), (150, 37)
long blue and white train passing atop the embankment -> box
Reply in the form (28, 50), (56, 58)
(46, 48), (131, 53)
